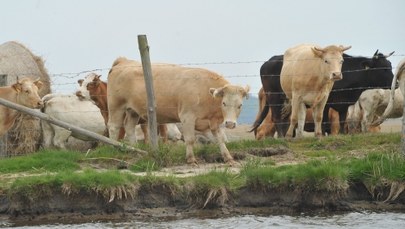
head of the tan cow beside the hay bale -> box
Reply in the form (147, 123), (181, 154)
(11, 78), (44, 109)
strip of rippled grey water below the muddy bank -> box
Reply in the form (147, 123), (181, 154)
(0, 212), (405, 229)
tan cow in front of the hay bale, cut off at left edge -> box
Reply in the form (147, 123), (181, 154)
(0, 78), (43, 136)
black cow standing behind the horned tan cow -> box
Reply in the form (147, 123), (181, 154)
(251, 50), (394, 137)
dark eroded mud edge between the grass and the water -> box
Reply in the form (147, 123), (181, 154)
(0, 183), (405, 226)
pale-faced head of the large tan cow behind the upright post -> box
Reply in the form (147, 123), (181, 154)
(210, 84), (250, 129)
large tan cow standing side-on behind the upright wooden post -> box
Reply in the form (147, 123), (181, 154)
(107, 57), (249, 164)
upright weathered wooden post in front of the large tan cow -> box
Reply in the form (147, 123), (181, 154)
(138, 35), (158, 151)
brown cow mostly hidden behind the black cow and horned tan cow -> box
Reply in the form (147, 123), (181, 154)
(255, 88), (340, 140)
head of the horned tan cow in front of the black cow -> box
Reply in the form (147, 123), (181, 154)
(312, 45), (351, 81)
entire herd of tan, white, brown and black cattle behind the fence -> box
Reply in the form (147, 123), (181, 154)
(0, 45), (405, 164)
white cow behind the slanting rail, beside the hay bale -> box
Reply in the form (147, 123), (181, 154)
(41, 94), (106, 149)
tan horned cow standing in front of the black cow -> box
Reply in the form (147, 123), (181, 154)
(280, 44), (350, 138)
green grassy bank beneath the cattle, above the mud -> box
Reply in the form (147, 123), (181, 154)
(0, 133), (405, 207)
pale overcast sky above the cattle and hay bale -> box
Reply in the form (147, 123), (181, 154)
(0, 0), (405, 93)
